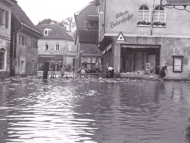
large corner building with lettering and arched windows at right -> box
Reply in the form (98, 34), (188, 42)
(96, 0), (190, 78)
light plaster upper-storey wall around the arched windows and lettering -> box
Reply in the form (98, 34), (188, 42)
(105, 0), (190, 36)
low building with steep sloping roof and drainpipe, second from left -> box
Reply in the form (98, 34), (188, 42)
(10, 4), (42, 76)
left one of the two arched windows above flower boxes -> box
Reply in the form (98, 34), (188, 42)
(138, 5), (150, 22)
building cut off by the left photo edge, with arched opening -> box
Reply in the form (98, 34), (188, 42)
(0, 0), (17, 78)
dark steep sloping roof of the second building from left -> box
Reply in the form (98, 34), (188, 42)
(12, 4), (40, 33)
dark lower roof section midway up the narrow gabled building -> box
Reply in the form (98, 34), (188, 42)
(78, 30), (98, 43)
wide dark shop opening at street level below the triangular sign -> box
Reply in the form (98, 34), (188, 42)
(120, 46), (160, 74)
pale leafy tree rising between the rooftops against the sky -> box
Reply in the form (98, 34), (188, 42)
(59, 17), (76, 31)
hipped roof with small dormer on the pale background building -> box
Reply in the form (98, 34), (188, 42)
(38, 23), (73, 41)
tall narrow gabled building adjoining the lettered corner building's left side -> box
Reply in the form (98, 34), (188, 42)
(74, 2), (102, 72)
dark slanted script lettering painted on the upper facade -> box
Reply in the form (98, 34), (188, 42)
(110, 10), (133, 28)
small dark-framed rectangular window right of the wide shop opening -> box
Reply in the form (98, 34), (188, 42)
(172, 55), (184, 73)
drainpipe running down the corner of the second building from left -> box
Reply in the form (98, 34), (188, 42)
(12, 23), (23, 75)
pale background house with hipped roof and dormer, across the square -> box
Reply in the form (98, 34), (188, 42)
(38, 23), (76, 70)
